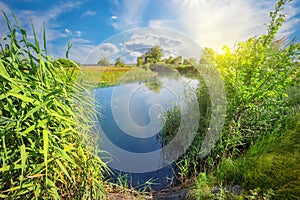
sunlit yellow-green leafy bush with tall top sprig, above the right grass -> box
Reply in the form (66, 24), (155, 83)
(214, 0), (300, 160)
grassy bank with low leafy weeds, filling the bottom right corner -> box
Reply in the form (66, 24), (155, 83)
(189, 111), (300, 199)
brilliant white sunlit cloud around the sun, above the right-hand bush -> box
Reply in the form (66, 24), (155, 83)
(156, 0), (299, 50)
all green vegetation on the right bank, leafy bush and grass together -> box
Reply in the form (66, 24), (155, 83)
(158, 0), (300, 199)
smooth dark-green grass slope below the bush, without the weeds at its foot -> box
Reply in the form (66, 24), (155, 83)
(217, 112), (300, 199)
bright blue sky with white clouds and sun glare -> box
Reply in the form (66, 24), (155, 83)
(0, 0), (300, 63)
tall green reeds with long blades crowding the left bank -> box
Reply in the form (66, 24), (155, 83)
(0, 13), (107, 199)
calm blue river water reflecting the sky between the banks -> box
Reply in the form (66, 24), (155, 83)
(95, 76), (198, 190)
